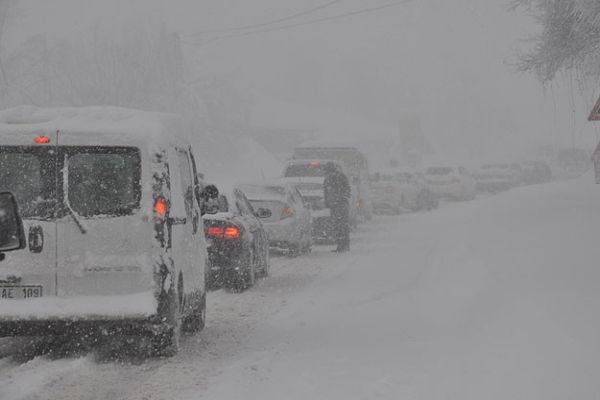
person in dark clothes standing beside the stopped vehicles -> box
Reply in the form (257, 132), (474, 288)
(323, 162), (351, 252)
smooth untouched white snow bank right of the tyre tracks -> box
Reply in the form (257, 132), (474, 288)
(195, 179), (600, 400)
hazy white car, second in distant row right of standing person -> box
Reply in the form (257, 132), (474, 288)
(425, 167), (476, 200)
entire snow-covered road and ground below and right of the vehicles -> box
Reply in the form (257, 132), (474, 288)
(0, 178), (600, 400)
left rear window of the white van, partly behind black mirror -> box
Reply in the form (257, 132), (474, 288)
(0, 146), (56, 220)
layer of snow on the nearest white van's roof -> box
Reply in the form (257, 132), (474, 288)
(0, 106), (188, 146)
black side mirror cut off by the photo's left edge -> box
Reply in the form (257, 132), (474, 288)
(0, 192), (27, 261)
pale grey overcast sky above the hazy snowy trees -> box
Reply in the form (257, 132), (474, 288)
(9, 0), (596, 162)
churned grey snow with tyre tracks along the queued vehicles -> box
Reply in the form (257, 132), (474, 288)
(0, 241), (342, 400)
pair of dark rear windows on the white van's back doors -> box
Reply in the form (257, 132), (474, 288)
(0, 146), (141, 220)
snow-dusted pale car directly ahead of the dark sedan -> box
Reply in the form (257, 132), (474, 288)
(237, 182), (312, 255)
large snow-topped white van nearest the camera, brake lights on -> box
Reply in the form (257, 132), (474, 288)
(0, 107), (207, 353)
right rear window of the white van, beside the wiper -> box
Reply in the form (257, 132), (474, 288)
(65, 147), (141, 217)
